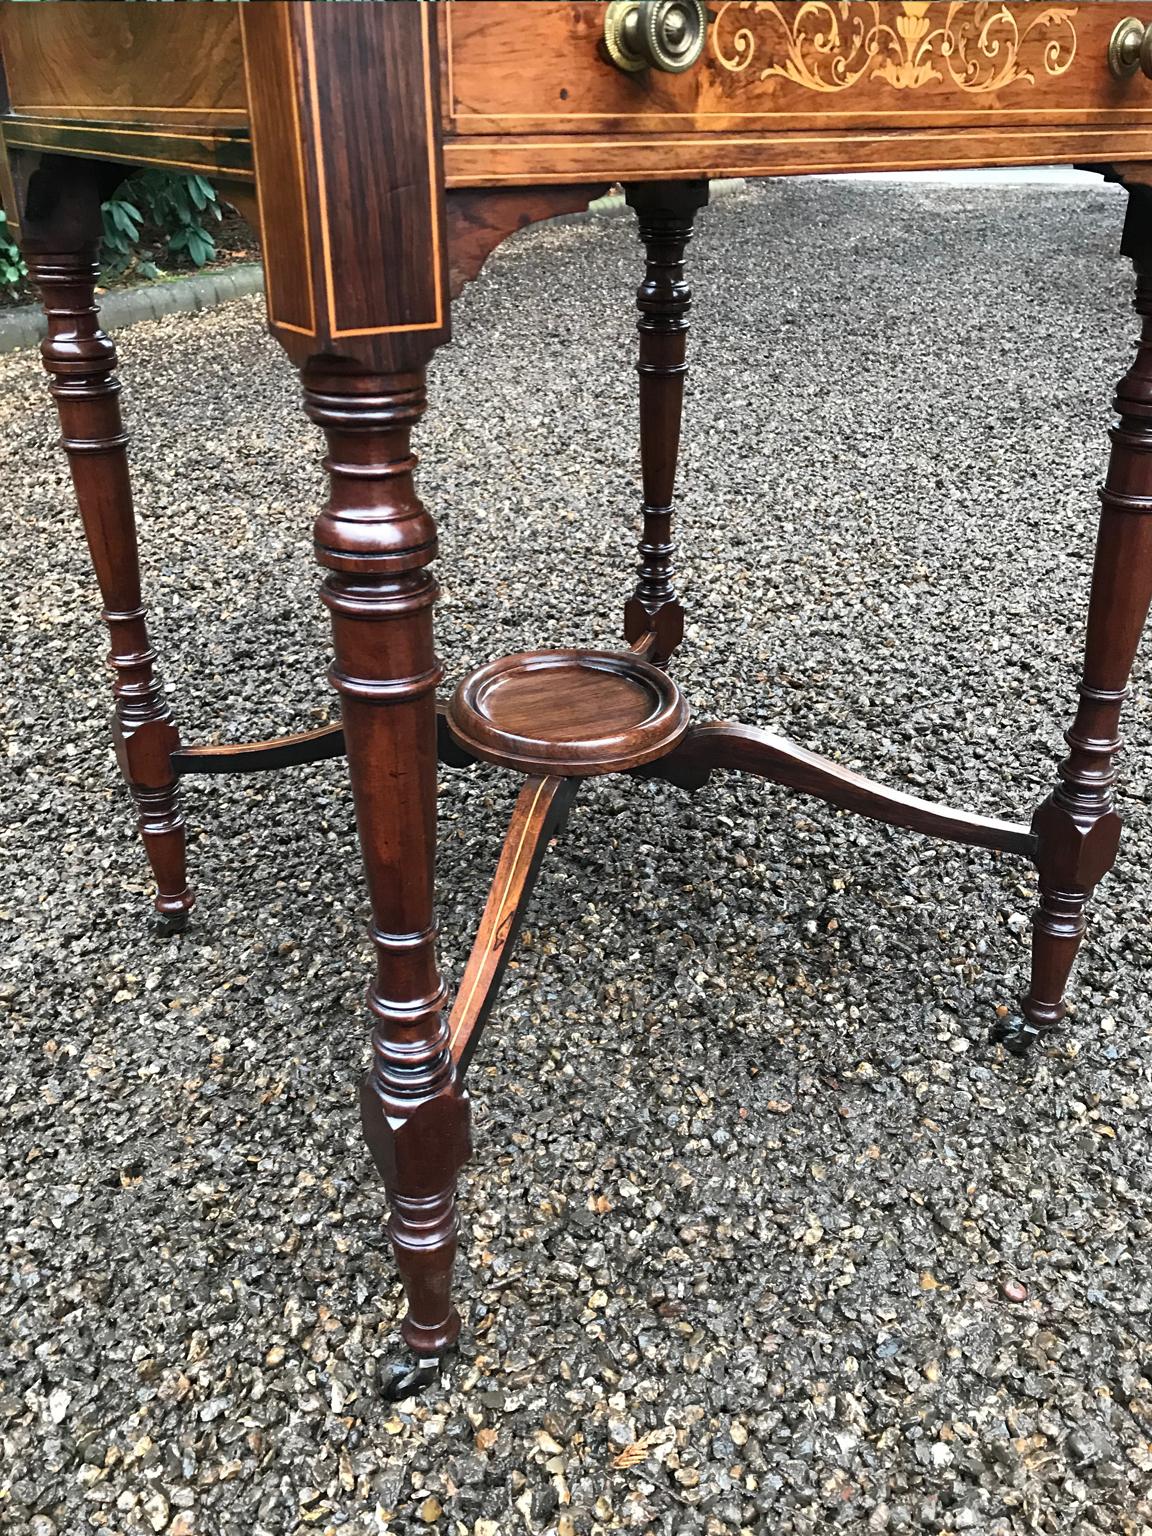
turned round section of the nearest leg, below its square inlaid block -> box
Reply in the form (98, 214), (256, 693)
(304, 359), (470, 1392)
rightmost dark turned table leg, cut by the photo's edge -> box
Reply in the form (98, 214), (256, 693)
(994, 187), (1152, 1051)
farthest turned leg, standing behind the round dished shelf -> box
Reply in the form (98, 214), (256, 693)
(624, 181), (708, 664)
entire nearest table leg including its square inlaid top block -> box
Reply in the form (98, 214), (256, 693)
(238, 0), (470, 1393)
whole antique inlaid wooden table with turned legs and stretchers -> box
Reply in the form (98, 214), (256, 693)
(0, 0), (1152, 1392)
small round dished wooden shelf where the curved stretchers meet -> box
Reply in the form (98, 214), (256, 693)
(449, 651), (688, 777)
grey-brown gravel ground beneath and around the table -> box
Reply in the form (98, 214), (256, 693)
(0, 183), (1152, 1536)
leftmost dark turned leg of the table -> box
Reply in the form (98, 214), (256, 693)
(25, 167), (194, 932)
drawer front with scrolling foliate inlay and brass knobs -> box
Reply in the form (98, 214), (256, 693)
(438, 0), (1152, 137)
